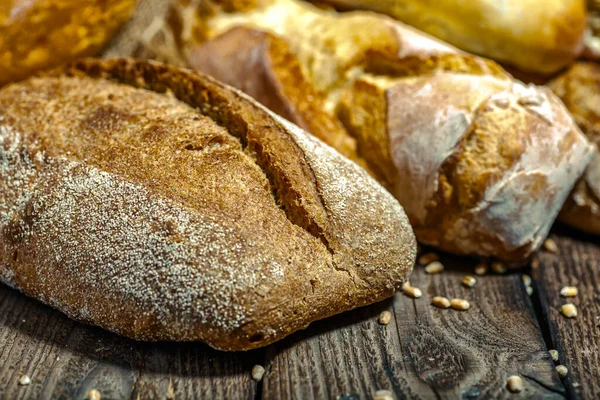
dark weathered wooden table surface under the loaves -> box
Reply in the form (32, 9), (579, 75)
(0, 228), (600, 400)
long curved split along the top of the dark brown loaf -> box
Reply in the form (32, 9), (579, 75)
(47, 59), (335, 255)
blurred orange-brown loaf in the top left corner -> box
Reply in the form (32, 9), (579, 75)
(0, 0), (136, 85)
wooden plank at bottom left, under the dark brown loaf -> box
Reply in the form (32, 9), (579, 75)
(0, 285), (262, 399)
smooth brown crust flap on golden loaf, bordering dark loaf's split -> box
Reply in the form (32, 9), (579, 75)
(189, 27), (357, 159)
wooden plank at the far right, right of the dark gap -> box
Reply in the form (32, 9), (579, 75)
(532, 231), (600, 399)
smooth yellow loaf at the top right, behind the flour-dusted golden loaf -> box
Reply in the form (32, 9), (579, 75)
(320, 0), (584, 75)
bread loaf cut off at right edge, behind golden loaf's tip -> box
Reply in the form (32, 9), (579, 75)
(549, 62), (600, 234)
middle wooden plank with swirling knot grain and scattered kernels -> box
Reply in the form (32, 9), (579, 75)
(263, 259), (564, 400)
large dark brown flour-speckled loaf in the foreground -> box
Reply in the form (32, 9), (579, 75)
(0, 59), (416, 350)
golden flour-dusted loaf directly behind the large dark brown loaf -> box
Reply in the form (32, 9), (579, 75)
(142, 0), (592, 261)
